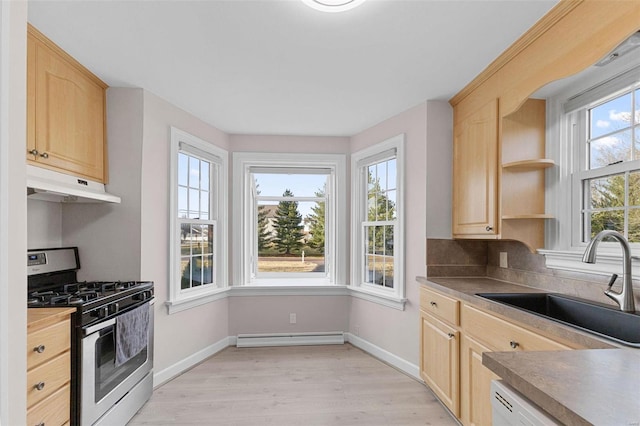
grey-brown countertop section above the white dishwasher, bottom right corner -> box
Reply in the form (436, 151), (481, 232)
(482, 349), (640, 425)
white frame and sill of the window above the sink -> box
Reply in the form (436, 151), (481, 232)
(538, 60), (640, 276)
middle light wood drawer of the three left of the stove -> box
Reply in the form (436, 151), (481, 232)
(27, 351), (71, 407)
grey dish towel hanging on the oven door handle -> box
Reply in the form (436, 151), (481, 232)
(116, 303), (149, 367)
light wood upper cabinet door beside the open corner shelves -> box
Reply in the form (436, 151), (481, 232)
(453, 100), (499, 238)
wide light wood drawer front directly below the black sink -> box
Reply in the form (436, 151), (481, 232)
(461, 305), (571, 351)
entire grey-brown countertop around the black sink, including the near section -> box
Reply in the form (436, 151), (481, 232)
(417, 277), (640, 425)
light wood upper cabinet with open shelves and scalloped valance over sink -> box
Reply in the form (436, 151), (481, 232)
(449, 0), (640, 250)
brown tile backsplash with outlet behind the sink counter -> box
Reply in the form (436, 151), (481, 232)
(427, 238), (632, 305)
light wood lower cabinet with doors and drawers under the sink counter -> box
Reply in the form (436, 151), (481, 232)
(420, 287), (574, 426)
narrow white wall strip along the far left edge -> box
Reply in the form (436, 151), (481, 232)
(0, 1), (27, 425)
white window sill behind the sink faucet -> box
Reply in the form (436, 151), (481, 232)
(538, 249), (640, 277)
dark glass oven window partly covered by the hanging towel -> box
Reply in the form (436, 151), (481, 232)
(95, 326), (147, 402)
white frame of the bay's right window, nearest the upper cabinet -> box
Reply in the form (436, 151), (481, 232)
(350, 134), (406, 310)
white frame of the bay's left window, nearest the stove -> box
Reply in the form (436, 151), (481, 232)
(166, 127), (228, 314)
